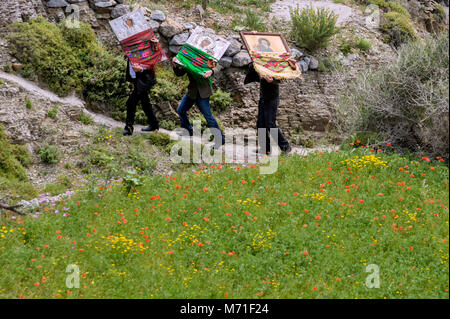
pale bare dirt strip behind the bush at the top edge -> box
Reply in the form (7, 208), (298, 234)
(270, 0), (355, 26)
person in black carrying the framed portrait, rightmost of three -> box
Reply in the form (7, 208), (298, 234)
(244, 64), (292, 154)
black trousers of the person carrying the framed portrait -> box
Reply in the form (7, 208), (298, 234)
(256, 96), (289, 152)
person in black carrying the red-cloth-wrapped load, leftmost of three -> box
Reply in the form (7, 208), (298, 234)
(123, 60), (159, 135)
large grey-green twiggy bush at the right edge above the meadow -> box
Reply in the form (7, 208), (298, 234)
(337, 34), (449, 158)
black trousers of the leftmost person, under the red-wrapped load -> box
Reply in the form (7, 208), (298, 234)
(126, 82), (159, 129)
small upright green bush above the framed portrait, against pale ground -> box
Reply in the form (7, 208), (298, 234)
(291, 6), (338, 51)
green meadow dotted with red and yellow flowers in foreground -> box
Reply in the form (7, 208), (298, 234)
(0, 141), (449, 298)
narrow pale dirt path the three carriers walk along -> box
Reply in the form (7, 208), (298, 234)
(0, 71), (336, 161)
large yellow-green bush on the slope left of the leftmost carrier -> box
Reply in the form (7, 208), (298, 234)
(8, 18), (129, 115)
